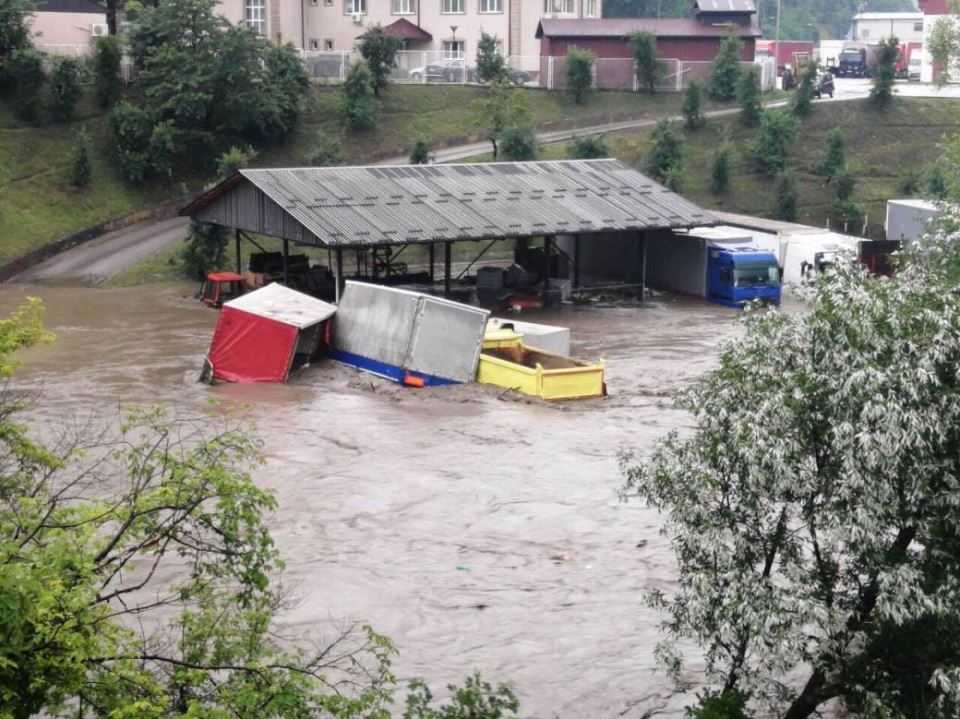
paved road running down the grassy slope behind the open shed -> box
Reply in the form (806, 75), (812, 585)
(10, 78), (960, 284)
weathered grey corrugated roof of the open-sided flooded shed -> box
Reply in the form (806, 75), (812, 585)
(181, 160), (716, 247)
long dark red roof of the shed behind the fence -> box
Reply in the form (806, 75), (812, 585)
(537, 17), (761, 38)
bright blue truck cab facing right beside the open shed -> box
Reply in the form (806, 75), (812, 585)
(707, 245), (780, 308)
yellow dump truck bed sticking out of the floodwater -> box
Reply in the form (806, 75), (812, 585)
(477, 340), (603, 399)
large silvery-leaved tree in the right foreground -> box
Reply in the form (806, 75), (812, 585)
(622, 212), (960, 719)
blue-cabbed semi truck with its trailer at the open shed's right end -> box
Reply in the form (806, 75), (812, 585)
(644, 227), (780, 308)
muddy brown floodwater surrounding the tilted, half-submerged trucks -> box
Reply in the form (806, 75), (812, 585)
(0, 285), (739, 718)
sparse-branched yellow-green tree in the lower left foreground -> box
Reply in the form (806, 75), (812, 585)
(0, 300), (393, 719)
